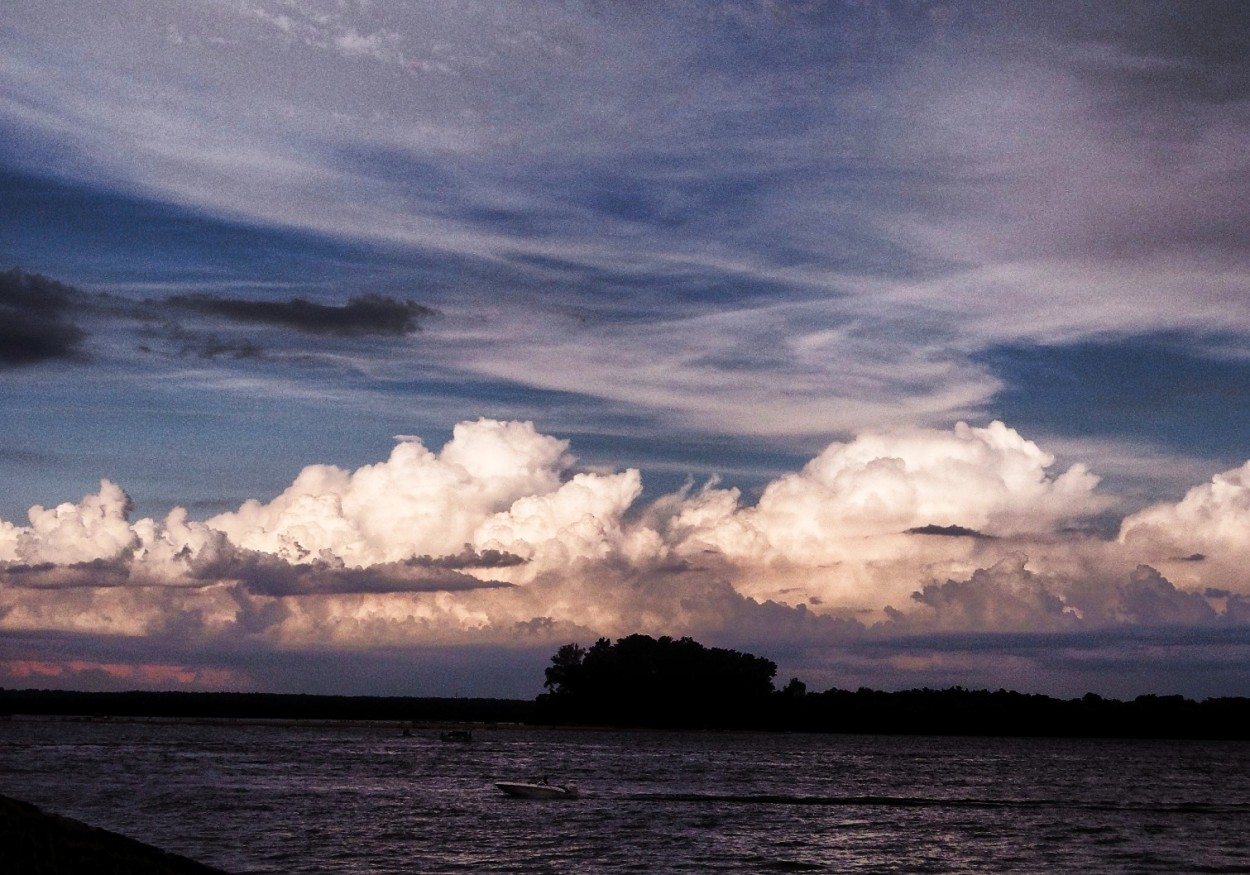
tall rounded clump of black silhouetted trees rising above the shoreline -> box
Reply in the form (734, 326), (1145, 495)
(538, 635), (778, 729)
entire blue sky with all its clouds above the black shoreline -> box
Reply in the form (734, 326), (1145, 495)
(0, 0), (1250, 699)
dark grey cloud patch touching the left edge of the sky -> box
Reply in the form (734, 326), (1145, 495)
(0, 269), (86, 368)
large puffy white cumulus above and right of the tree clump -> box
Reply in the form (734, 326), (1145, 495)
(669, 423), (1108, 611)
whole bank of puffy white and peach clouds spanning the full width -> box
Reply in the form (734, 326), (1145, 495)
(0, 419), (1250, 695)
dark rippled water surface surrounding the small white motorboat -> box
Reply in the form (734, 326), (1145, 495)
(0, 720), (1250, 875)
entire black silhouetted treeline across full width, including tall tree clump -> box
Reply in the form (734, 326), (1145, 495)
(7, 655), (1250, 740)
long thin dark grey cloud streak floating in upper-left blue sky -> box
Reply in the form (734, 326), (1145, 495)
(169, 295), (434, 338)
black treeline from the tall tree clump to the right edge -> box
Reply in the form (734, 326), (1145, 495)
(538, 635), (1250, 739)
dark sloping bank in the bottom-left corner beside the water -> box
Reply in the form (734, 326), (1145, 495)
(0, 796), (225, 875)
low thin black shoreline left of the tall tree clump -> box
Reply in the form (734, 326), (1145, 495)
(0, 688), (535, 723)
